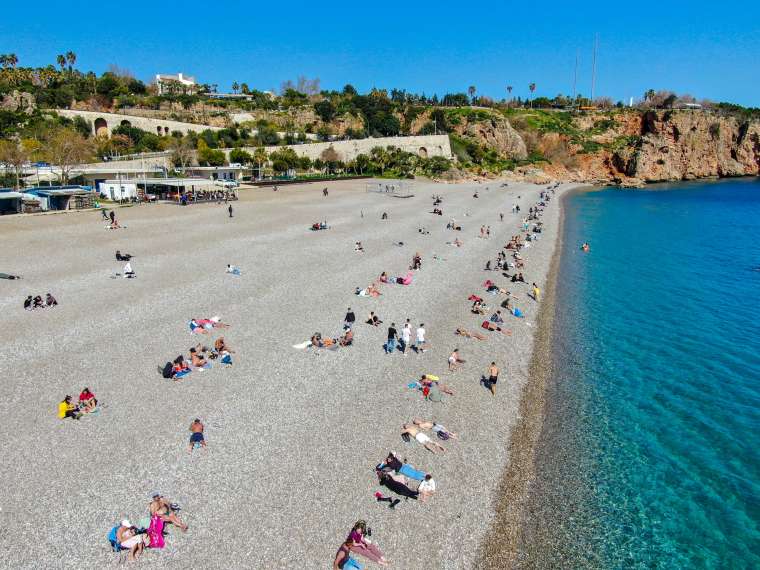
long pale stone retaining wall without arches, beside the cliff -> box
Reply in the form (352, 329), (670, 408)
(235, 135), (452, 162)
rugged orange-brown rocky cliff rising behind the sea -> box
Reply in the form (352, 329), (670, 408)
(455, 110), (760, 186)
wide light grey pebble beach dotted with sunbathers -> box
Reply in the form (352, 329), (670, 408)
(0, 176), (572, 570)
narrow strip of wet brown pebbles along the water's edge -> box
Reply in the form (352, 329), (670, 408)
(477, 186), (576, 570)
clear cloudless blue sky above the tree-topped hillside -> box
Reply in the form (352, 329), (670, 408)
(0, 0), (760, 107)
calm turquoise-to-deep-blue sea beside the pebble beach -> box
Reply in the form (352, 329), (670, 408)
(525, 179), (760, 568)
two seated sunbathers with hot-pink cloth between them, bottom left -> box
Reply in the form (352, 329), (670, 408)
(108, 493), (188, 560)
